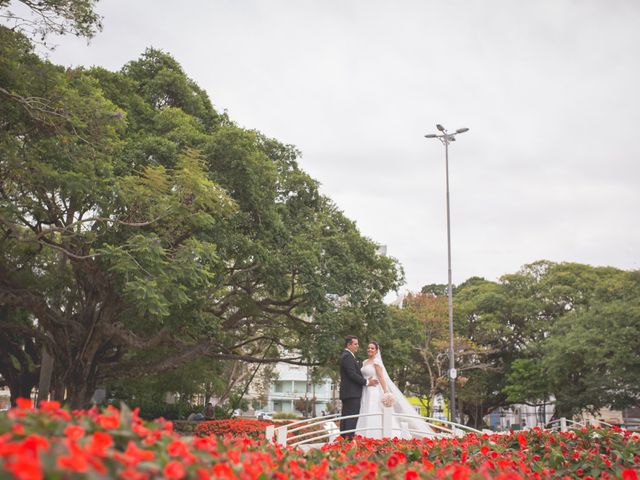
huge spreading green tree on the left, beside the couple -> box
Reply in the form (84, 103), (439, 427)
(0, 29), (399, 406)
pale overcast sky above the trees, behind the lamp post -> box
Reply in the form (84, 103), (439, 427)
(38, 0), (640, 291)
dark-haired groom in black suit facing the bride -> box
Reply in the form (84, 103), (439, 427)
(340, 335), (378, 438)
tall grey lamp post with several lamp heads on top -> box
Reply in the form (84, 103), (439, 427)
(425, 124), (469, 422)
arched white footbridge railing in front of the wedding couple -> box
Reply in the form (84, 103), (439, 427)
(265, 407), (482, 446)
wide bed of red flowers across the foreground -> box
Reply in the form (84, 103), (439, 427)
(0, 401), (640, 480)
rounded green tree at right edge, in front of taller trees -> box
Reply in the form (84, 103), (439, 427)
(536, 284), (640, 413)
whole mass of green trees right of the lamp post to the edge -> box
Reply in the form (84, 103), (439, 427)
(414, 261), (640, 427)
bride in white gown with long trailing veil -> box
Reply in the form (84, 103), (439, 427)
(356, 342), (434, 438)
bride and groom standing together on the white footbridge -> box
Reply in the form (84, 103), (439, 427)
(340, 335), (433, 438)
